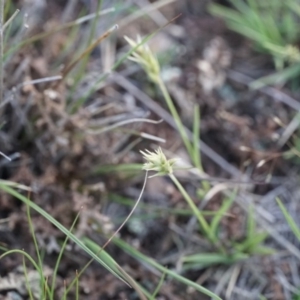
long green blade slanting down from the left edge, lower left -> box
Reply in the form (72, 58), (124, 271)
(0, 184), (130, 283)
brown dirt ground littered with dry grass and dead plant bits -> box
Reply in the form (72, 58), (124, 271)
(0, 0), (300, 300)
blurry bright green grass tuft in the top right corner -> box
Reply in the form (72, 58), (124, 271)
(209, 0), (300, 88)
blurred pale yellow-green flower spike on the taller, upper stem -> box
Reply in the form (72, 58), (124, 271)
(124, 36), (160, 83)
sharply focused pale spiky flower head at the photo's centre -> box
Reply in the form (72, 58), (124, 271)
(140, 147), (177, 177)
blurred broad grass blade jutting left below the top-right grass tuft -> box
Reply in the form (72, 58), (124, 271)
(250, 62), (300, 89)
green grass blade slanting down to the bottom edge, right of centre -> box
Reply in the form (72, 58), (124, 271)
(113, 238), (222, 300)
